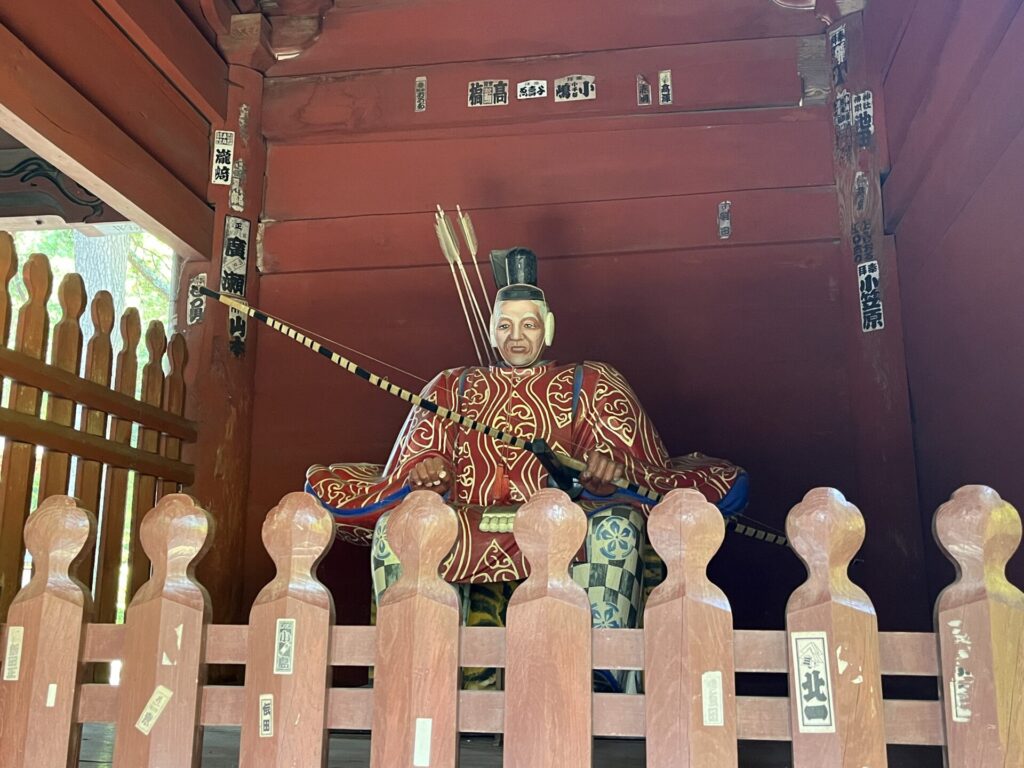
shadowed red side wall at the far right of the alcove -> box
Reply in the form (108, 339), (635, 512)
(866, 0), (1024, 591)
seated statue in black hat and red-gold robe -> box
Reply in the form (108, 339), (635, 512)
(306, 248), (746, 690)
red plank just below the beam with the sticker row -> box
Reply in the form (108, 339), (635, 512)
(264, 108), (834, 220)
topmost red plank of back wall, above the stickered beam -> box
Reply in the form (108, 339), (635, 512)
(267, 0), (823, 76)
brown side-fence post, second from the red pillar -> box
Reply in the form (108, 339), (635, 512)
(128, 321), (167, 597)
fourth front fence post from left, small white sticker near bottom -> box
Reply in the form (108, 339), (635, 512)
(370, 490), (459, 768)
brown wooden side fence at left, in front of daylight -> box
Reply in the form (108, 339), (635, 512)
(0, 232), (196, 622)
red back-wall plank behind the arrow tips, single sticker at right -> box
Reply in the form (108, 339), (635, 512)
(260, 185), (840, 274)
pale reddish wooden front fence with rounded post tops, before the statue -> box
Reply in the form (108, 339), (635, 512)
(0, 486), (1024, 768)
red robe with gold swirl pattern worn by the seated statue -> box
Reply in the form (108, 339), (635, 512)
(306, 361), (743, 582)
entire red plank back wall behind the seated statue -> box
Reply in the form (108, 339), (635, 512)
(246, 0), (927, 628)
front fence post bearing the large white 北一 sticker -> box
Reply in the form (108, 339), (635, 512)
(785, 488), (887, 768)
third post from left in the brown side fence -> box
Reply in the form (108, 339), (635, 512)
(39, 272), (86, 499)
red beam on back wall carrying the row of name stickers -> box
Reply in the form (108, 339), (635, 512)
(263, 38), (804, 141)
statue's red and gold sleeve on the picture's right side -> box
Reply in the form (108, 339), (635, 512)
(573, 362), (742, 503)
